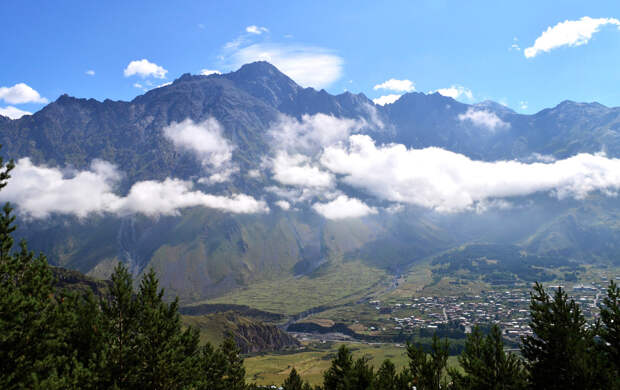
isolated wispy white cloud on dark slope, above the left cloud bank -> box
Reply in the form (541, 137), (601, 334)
(162, 118), (234, 168)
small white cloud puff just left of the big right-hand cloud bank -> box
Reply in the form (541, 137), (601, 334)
(272, 151), (334, 188)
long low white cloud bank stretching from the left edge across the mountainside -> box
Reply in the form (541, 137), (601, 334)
(0, 158), (268, 218)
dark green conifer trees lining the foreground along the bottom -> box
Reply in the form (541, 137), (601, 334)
(0, 153), (620, 390)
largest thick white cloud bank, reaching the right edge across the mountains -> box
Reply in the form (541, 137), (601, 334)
(321, 134), (620, 212)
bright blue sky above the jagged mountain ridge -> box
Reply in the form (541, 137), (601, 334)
(0, 0), (620, 117)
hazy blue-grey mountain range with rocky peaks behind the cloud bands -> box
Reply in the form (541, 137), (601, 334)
(0, 62), (620, 302)
